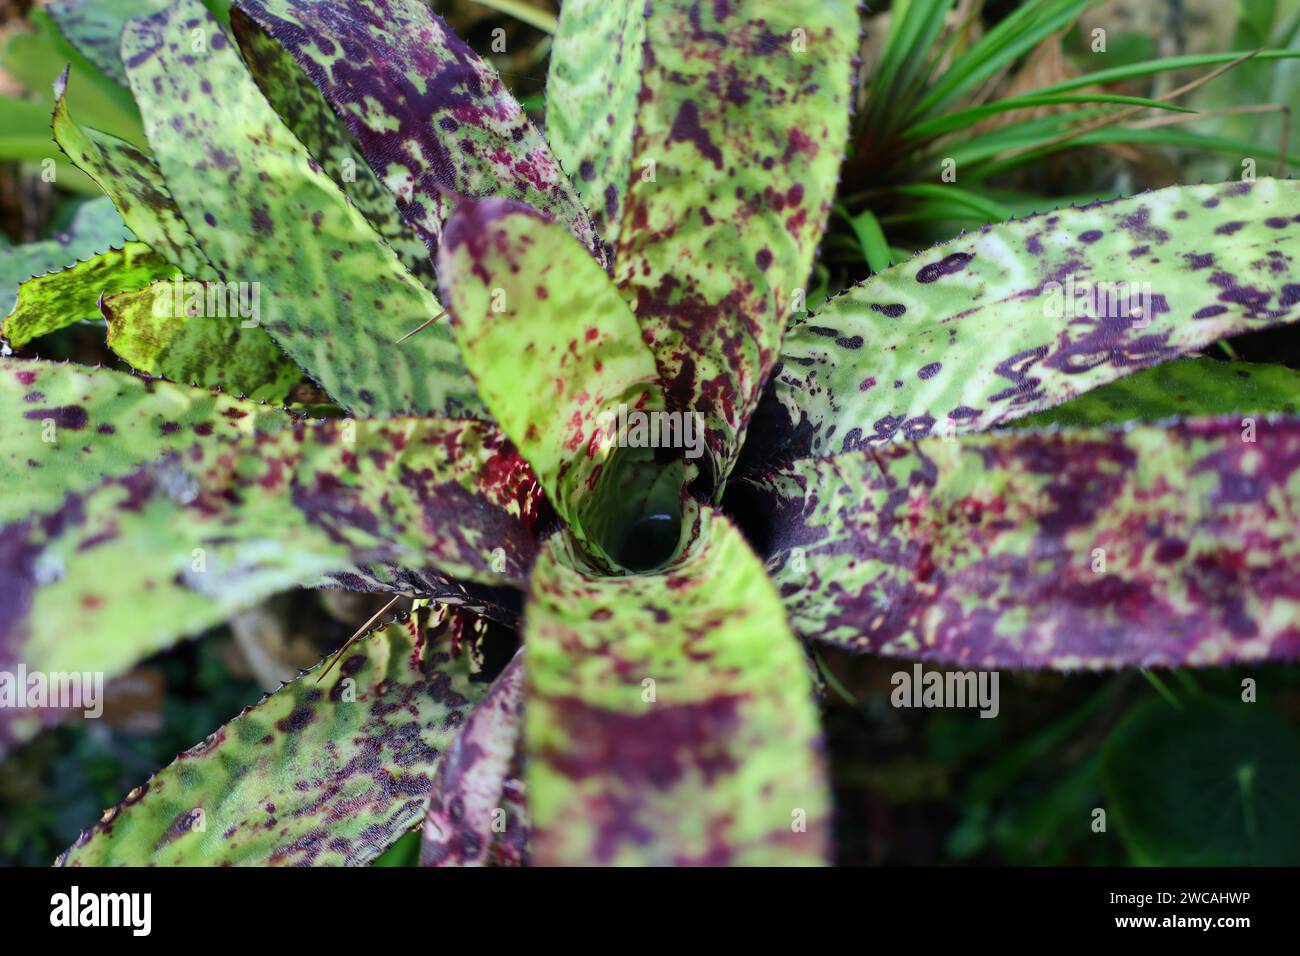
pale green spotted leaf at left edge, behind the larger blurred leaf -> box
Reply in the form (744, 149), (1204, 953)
(0, 358), (293, 524)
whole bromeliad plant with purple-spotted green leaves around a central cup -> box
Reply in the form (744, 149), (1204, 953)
(0, 0), (1300, 864)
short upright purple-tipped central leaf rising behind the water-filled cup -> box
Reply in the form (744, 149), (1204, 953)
(438, 199), (679, 564)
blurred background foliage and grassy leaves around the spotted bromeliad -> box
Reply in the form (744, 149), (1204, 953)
(0, 0), (1300, 866)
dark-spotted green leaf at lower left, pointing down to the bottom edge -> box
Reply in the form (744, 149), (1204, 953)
(59, 609), (482, 866)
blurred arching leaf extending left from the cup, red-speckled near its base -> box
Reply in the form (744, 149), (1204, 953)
(0, 385), (550, 759)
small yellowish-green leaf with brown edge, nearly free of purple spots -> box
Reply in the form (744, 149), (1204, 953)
(99, 277), (303, 402)
